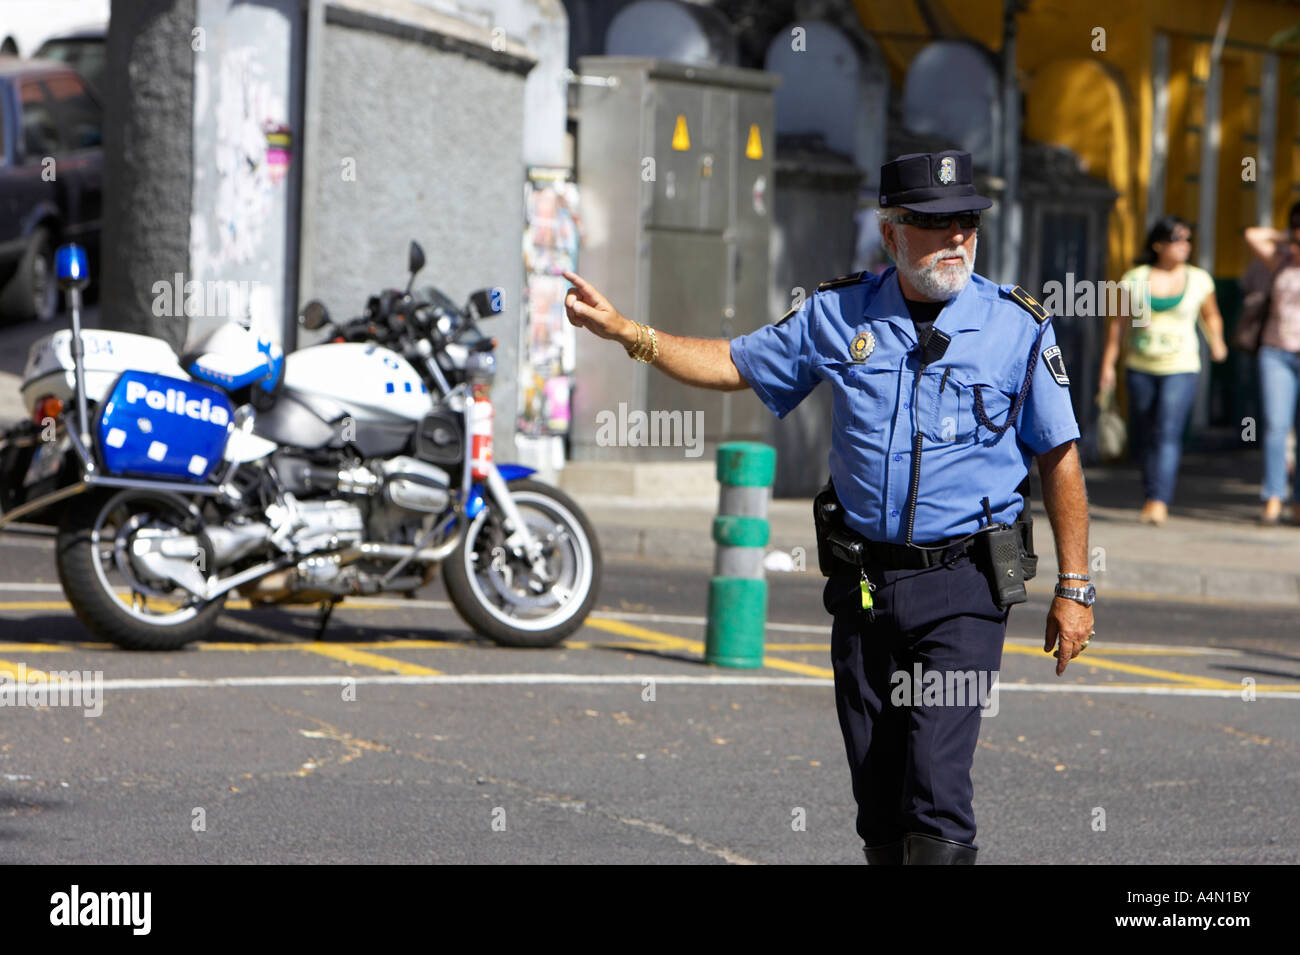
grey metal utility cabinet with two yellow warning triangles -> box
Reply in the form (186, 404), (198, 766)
(572, 56), (779, 461)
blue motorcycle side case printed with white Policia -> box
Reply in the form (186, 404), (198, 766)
(98, 372), (233, 481)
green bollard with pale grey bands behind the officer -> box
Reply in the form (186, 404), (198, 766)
(705, 442), (776, 668)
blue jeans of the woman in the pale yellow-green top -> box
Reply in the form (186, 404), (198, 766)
(1127, 369), (1200, 504)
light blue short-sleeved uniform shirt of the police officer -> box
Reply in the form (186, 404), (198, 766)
(731, 268), (1079, 544)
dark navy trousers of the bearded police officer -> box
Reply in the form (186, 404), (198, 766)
(823, 556), (1009, 847)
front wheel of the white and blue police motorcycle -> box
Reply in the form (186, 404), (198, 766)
(442, 479), (601, 647)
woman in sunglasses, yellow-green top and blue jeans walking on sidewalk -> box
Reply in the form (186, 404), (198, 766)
(1100, 216), (1227, 525)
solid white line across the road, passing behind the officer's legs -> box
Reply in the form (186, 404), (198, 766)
(5, 673), (1300, 699)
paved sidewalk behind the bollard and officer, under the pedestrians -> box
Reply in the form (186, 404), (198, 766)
(573, 452), (1300, 608)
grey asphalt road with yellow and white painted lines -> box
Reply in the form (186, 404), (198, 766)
(0, 537), (1300, 864)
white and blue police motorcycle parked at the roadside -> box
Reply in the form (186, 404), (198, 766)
(0, 243), (601, 650)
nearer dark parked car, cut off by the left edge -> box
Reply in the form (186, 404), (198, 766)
(0, 56), (104, 321)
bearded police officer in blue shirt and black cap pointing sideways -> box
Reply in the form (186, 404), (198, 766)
(564, 151), (1095, 864)
